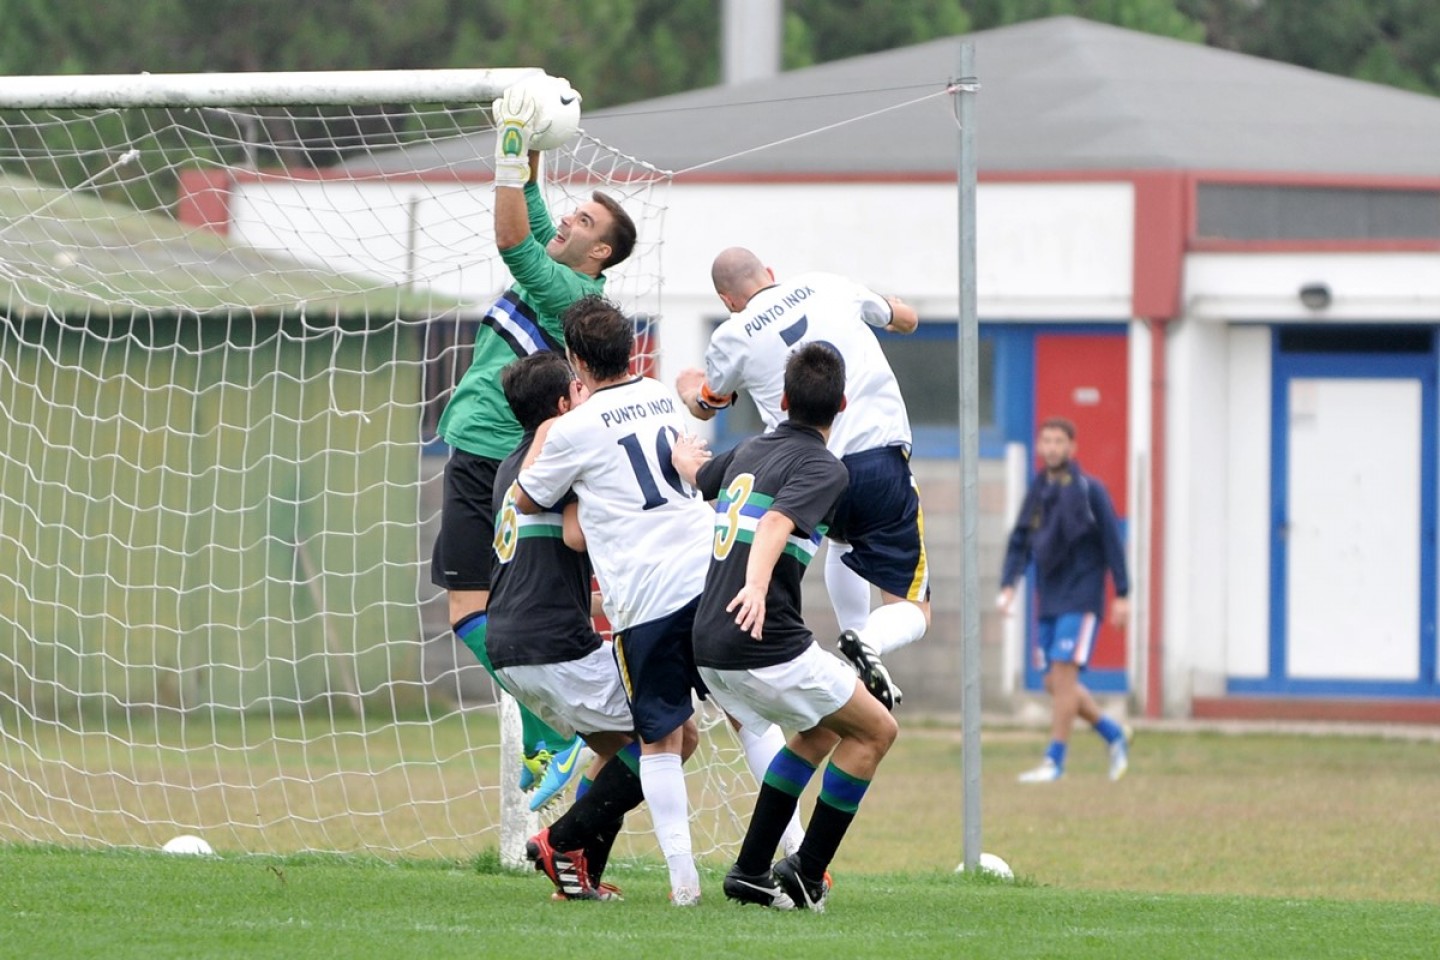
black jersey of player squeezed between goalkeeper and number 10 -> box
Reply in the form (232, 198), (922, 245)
(485, 433), (603, 668)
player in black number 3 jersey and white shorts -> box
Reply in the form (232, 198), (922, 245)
(672, 343), (899, 911)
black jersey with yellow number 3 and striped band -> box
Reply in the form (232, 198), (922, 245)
(694, 422), (850, 669)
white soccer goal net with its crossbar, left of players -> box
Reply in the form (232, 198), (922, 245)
(0, 71), (753, 859)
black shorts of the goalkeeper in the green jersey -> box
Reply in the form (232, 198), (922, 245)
(431, 450), (500, 590)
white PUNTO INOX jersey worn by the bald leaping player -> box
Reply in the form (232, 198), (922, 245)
(706, 273), (910, 456)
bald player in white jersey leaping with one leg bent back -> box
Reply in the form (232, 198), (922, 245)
(675, 248), (930, 708)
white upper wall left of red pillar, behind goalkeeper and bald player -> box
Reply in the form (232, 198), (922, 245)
(230, 177), (1135, 336)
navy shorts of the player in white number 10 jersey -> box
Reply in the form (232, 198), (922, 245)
(612, 597), (710, 743)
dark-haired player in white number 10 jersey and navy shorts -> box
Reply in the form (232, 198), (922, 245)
(516, 296), (785, 905)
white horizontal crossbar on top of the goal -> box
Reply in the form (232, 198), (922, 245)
(0, 68), (544, 109)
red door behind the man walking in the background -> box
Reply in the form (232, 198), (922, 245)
(1030, 334), (1135, 679)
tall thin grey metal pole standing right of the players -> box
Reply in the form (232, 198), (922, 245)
(955, 40), (981, 872)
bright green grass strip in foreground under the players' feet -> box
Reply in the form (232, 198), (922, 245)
(0, 846), (1440, 960)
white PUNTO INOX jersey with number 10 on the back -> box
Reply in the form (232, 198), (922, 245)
(520, 377), (714, 630)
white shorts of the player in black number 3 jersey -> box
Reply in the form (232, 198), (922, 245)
(700, 643), (860, 731)
